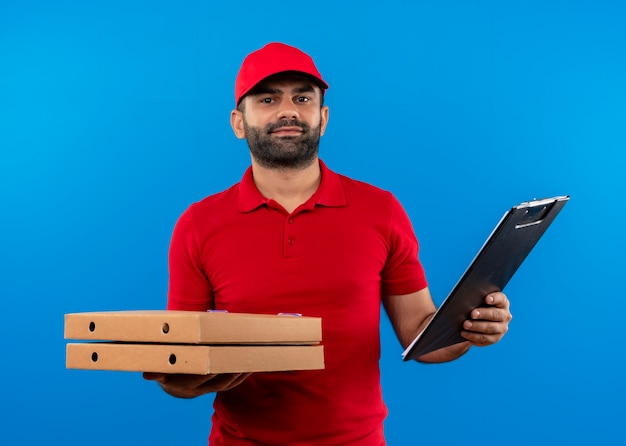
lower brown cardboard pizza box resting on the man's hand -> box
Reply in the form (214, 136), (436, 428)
(66, 342), (324, 375)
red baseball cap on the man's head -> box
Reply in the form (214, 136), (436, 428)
(235, 42), (328, 105)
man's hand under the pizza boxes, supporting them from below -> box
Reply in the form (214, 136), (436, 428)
(143, 372), (251, 398)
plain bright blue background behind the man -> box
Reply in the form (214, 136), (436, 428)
(0, 0), (626, 445)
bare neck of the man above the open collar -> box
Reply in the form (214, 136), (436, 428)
(252, 158), (322, 213)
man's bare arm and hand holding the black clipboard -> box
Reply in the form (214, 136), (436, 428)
(383, 288), (513, 362)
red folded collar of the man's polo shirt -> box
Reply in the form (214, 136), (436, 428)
(239, 159), (346, 212)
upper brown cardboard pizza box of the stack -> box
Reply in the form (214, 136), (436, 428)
(65, 310), (322, 345)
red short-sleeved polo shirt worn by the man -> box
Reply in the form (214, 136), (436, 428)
(168, 161), (427, 446)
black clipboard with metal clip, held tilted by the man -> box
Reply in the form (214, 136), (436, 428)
(402, 195), (569, 361)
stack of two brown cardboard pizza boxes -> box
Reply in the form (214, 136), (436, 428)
(64, 310), (324, 375)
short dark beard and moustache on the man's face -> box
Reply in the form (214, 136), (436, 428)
(243, 119), (320, 170)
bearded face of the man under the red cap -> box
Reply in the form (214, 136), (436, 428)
(231, 75), (328, 169)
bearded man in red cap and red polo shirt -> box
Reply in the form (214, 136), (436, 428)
(144, 43), (511, 446)
